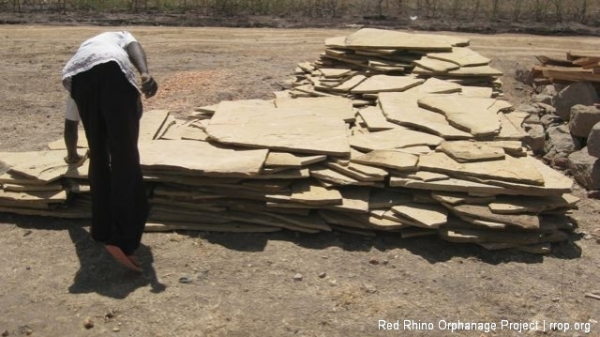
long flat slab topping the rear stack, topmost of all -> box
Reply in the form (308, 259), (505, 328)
(345, 28), (452, 51)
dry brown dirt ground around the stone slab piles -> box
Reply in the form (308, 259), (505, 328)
(0, 25), (600, 336)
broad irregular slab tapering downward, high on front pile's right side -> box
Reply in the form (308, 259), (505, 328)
(418, 95), (512, 137)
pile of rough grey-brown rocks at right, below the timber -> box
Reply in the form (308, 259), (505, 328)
(517, 53), (600, 197)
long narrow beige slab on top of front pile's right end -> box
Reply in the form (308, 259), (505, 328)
(419, 152), (544, 186)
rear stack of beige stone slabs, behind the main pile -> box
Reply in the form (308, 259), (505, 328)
(290, 28), (502, 105)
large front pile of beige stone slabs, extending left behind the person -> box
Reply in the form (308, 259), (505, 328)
(0, 28), (578, 253)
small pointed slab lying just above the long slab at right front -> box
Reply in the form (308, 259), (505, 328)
(437, 141), (505, 163)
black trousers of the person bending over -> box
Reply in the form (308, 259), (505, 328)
(71, 62), (148, 255)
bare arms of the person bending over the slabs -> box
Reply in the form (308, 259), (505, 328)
(64, 42), (158, 164)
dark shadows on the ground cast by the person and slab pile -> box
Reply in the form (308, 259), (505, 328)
(0, 214), (582, 280)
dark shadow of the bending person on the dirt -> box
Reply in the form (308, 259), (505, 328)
(69, 226), (166, 299)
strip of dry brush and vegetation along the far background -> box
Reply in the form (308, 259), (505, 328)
(0, 0), (600, 26)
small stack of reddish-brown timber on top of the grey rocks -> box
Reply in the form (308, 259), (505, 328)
(532, 51), (600, 85)
